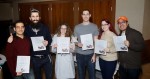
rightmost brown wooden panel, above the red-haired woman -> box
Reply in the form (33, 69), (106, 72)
(93, 0), (112, 27)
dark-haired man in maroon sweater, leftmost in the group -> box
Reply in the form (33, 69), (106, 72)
(6, 21), (33, 79)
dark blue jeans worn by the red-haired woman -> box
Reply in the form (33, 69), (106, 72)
(99, 58), (117, 79)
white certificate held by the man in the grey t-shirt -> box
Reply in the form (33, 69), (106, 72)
(80, 34), (94, 50)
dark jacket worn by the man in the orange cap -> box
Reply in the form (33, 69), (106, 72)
(118, 26), (144, 69)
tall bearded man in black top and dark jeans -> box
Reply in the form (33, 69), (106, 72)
(25, 9), (52, 79)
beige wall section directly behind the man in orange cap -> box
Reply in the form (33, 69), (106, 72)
(116, 0), (145, 32)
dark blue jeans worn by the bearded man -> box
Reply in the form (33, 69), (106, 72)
(31, 55), (52, 79)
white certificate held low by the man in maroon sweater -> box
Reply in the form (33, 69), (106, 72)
(16, 56), (30, 73)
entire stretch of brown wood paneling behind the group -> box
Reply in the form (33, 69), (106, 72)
(19, 0), (116, 33)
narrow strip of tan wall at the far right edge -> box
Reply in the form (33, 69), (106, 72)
(143, 0), (150, 40)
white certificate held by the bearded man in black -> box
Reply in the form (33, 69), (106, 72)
(31, 36), (46, 51)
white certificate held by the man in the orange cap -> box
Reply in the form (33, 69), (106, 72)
(113, 36), (128, 51)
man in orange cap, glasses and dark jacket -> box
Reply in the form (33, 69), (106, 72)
(117, 16), (144, 79)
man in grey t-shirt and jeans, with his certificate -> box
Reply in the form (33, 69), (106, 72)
(74, 10), (99, 79)
